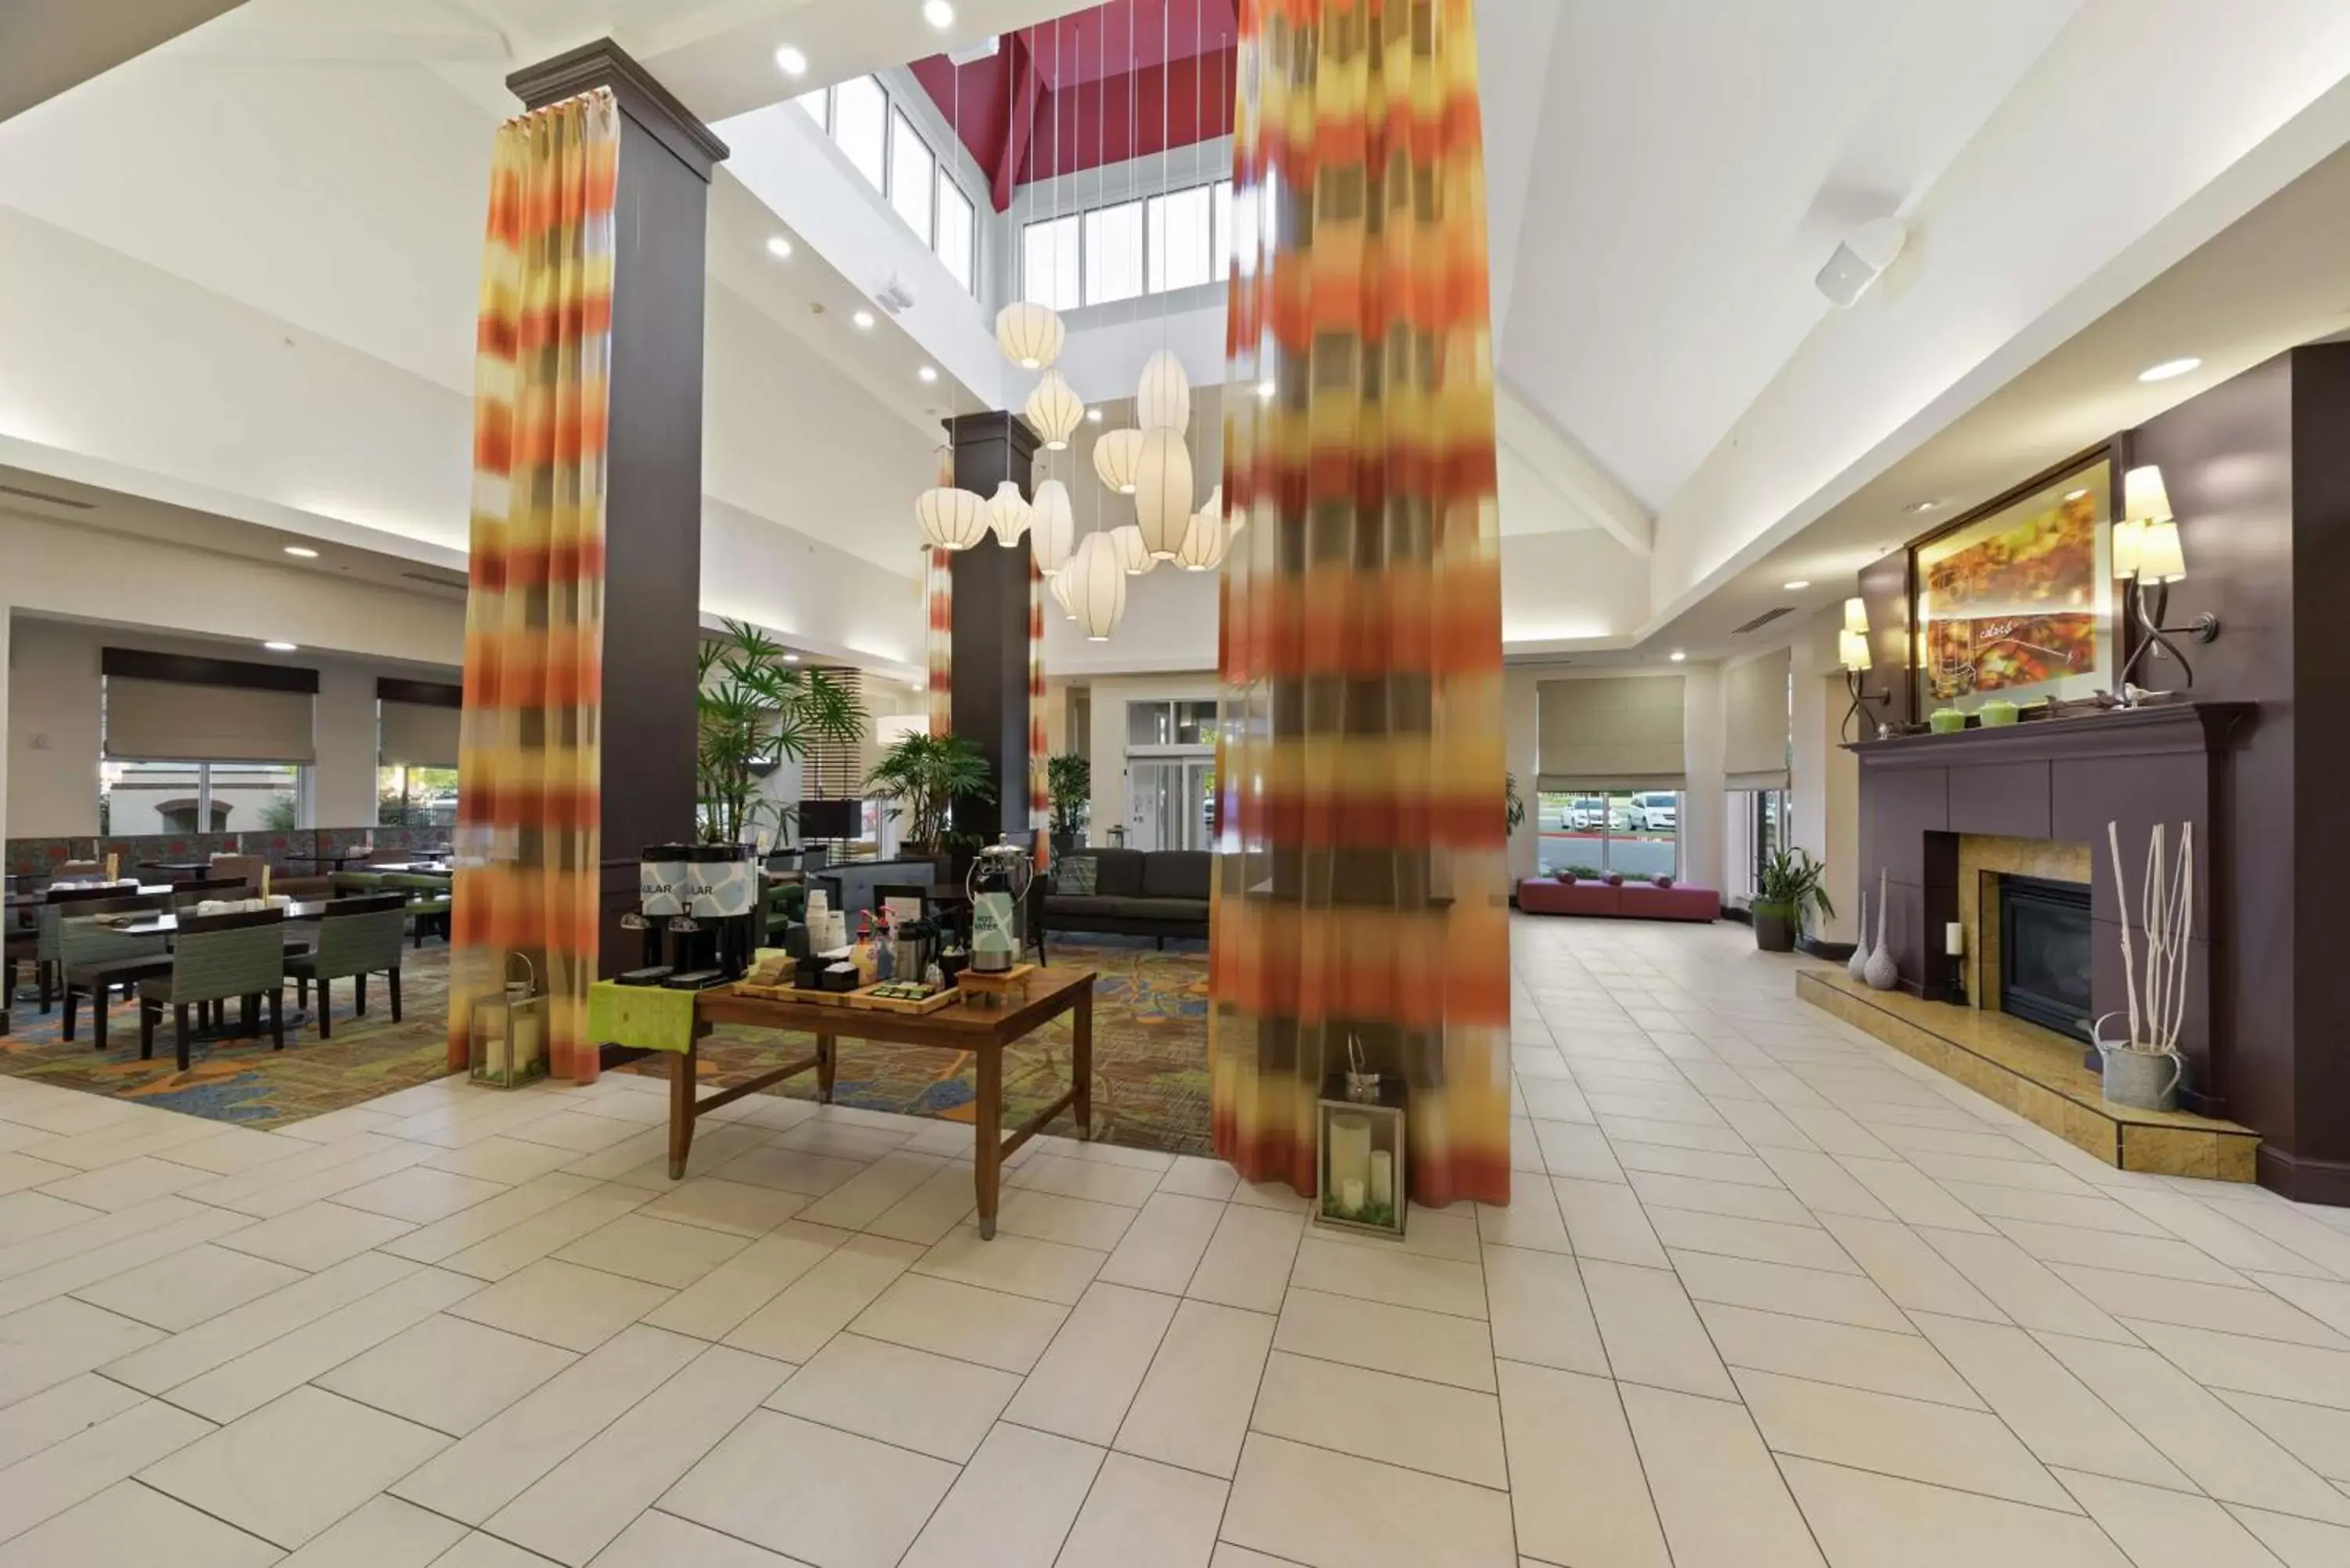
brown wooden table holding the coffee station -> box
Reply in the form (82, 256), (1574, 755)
(670, 969), (1093, 1239)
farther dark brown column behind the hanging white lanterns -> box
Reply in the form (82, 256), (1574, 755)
(947, 414), (1036, 842)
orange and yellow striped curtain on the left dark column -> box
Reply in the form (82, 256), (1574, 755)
(449, 89), (620, 1082)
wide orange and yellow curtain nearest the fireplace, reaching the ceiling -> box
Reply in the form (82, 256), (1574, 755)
(1210, 0), (1509, 1204)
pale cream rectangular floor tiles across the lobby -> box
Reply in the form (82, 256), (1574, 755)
(0, 919), (2350, 1568)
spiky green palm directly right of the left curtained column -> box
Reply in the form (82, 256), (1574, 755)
(693, 620), (867, 844)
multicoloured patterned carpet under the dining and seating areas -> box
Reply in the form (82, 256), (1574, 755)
(0, 938), (1208, 1154)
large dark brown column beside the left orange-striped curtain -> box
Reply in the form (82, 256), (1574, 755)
(505, 38), (726, 974)
